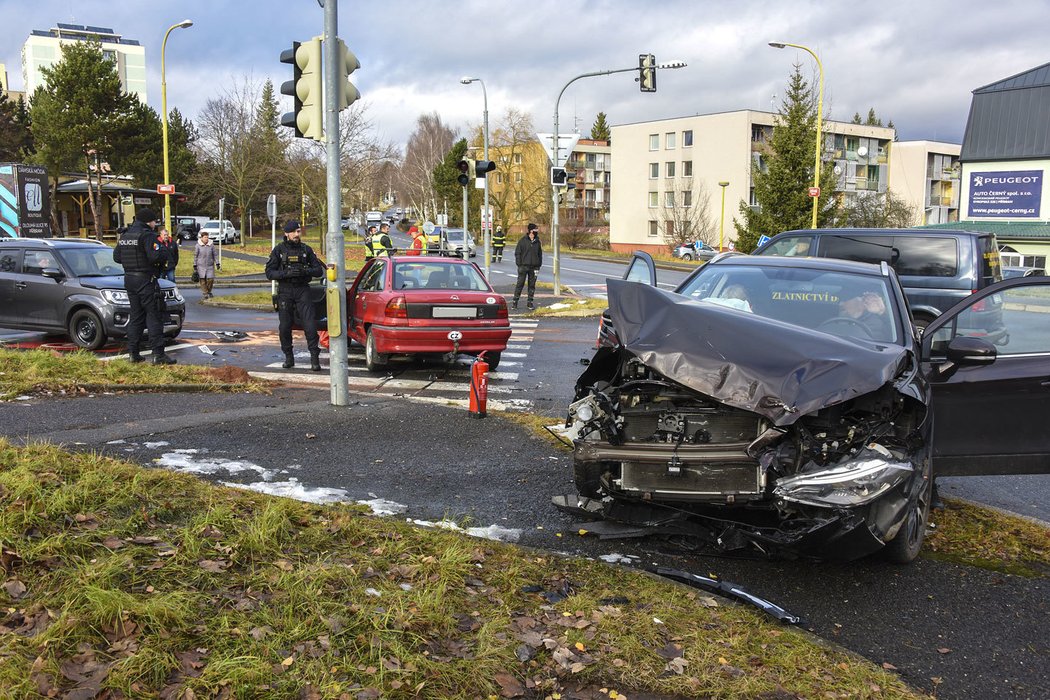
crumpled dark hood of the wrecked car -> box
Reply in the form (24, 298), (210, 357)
(608, 279), (909, 426)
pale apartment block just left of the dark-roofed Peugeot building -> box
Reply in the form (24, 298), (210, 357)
(889, 141), (963, 226)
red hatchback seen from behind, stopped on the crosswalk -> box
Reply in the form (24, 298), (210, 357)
(347, 256), (510, 372)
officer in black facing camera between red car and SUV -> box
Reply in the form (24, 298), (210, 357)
(266, 219), (324, 372)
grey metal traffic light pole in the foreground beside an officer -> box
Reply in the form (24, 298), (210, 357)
(323, 0), (350, 406)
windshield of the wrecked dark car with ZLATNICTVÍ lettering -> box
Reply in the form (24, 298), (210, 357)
(678, 264), (901, 343)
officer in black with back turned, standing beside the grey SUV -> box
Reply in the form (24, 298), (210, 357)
(113, 209), (175, 364)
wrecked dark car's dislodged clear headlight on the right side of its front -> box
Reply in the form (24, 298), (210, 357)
(773, 445), (915, 508)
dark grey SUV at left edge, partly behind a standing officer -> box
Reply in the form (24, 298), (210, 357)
(0, 238), (186, 349)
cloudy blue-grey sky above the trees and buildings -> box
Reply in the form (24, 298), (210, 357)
(0, 0), (1050, 152)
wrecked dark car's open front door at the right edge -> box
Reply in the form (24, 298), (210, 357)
(922, 277), (1050, 476)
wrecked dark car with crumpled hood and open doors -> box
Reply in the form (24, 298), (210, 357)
(565, 254), (1050, 563)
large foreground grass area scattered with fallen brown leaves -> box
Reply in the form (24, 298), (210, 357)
(0, 441), (921, 698)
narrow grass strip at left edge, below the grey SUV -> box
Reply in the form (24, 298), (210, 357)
(0, 348), (269, 400)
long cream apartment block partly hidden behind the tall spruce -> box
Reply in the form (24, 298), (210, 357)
(609, 109), (895, 252)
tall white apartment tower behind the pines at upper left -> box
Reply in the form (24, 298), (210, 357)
(22, 23), (146, 104)
